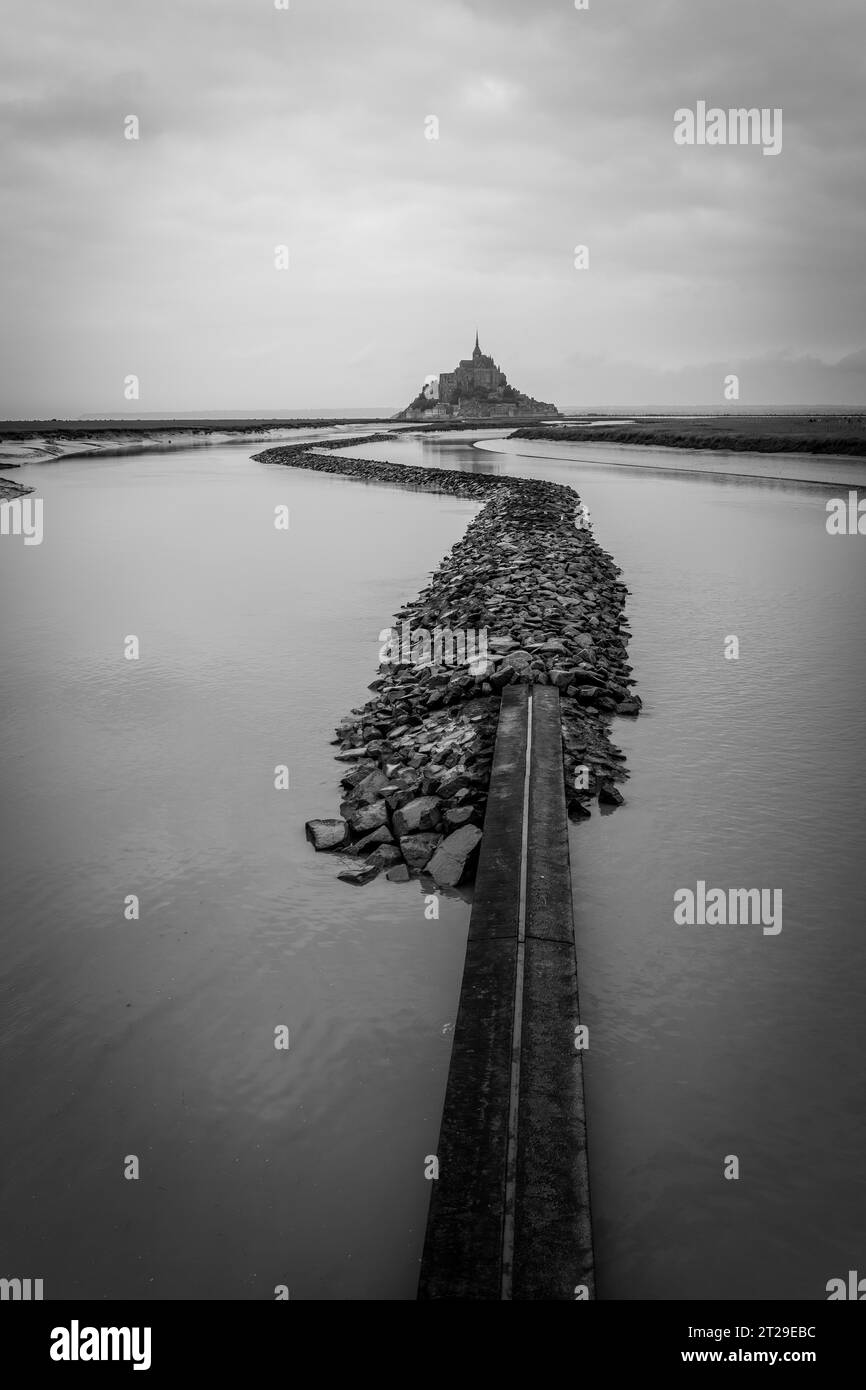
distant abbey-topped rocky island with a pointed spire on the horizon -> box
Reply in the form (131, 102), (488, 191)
(395, 332), (559, 420)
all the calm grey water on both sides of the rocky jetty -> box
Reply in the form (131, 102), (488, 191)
(0, 435), (866, 1298)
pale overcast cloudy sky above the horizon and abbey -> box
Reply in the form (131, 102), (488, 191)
(0, 0), (866, 418)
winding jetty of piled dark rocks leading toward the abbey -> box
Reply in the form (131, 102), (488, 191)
(256, 435), (641, 888)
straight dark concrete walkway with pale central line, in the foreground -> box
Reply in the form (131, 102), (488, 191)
(418, 685), (595, 1300)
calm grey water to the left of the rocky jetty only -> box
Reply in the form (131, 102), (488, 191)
(0, 445), (478, 1298)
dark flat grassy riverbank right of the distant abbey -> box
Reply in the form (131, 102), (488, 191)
(512, 411), (866, 457)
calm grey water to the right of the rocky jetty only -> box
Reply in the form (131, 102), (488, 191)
(339, 425), (866, 1300)
